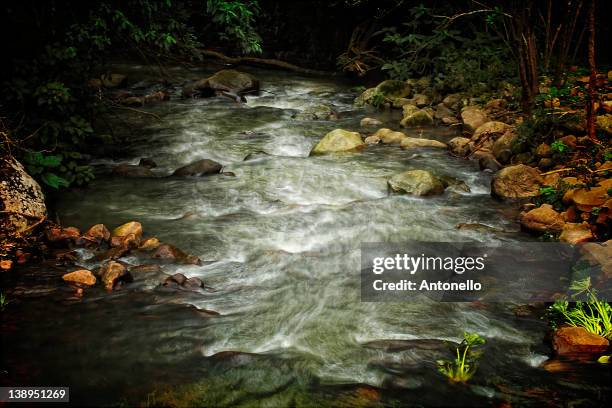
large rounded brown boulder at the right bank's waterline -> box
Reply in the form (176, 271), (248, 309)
(491, 164), (543, 199)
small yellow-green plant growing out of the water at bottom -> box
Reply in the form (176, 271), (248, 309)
(437, 332), (485, 383)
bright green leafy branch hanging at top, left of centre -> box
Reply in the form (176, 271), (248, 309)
(206, 0), (261, 54)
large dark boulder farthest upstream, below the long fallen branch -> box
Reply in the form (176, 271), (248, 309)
(183, 69), (259, 97)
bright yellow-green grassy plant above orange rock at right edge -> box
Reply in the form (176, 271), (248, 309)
(548, 277), (612, 339)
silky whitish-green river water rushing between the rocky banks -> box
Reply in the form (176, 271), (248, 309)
(3, 65), (610, 407)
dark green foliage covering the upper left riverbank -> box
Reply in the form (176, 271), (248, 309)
(0, 0), (261, 189)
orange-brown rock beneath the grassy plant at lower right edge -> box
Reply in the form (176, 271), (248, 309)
(553, 327), (610, 358)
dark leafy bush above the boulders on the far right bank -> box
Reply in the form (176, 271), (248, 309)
(382, 4), (515, 94)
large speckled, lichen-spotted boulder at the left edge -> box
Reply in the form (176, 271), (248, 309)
(0, 157), (47, 239)
